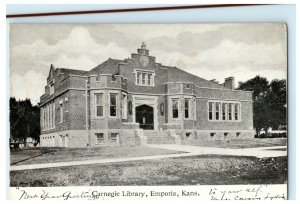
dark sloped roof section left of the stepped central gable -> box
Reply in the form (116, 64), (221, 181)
(87, 58), (124, 75)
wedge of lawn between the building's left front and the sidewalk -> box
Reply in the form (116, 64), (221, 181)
(10, 146), (182, 165)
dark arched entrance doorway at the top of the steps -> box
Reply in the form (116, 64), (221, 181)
(135, 104), (154, 130)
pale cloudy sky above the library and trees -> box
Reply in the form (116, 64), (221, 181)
(9, 23), (287, 104)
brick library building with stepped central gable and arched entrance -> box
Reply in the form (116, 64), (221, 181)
(40, 44), (254, 147)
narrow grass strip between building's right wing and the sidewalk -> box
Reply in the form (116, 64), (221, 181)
(191, 138), (287, 149)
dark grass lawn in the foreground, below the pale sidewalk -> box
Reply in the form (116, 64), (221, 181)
(10, 155), (287, 186)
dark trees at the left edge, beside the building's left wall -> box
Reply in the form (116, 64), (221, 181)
(9, 97), (40, 143)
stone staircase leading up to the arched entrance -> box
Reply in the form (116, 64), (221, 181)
(144, 130), (175, 144)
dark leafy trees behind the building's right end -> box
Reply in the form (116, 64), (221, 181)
(238, 76), (286, 135)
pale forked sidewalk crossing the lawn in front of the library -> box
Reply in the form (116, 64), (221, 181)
(10, 144), (287, 171)
